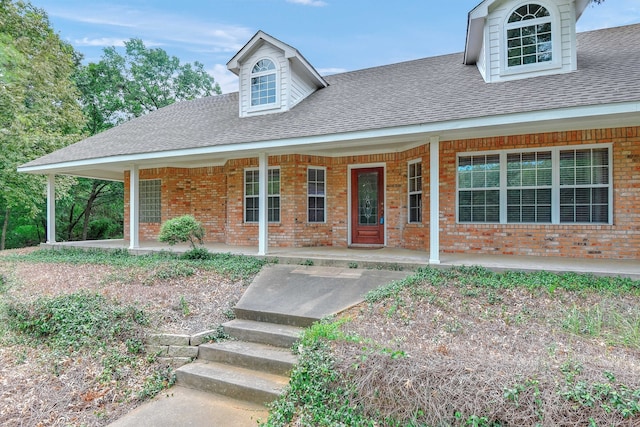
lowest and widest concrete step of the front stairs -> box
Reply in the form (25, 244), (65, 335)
(176, 360), (289, 404)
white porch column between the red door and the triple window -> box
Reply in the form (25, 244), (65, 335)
(429, 136), (440, 264)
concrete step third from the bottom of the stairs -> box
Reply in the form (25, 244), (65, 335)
(222, 319), (302, 348)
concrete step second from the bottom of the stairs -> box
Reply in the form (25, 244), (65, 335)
(198, 341), (297, 376)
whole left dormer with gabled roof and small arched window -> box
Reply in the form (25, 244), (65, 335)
(227, 31), (328, 117)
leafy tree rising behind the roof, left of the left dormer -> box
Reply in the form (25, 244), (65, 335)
(76, 39), (221, 128)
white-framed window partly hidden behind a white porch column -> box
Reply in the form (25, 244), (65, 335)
(244, 168), (280, 222)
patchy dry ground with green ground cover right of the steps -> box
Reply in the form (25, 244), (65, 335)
(265, 267), (640, 426)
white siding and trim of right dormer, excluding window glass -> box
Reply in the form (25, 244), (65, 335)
(465, 0), (584, 82)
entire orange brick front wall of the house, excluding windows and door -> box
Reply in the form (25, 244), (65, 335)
(125, 127), (640, 258)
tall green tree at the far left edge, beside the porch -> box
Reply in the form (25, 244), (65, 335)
(0, 0), (84, 250)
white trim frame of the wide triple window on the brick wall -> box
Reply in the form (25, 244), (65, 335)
(455, 143), (614, 226)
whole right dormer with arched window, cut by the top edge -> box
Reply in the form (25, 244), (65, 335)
(464, 0), (591, 83)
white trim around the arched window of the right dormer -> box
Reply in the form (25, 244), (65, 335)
(500, 0), (562, 77)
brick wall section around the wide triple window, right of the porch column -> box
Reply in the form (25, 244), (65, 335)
(440, 127), (640, 259)
